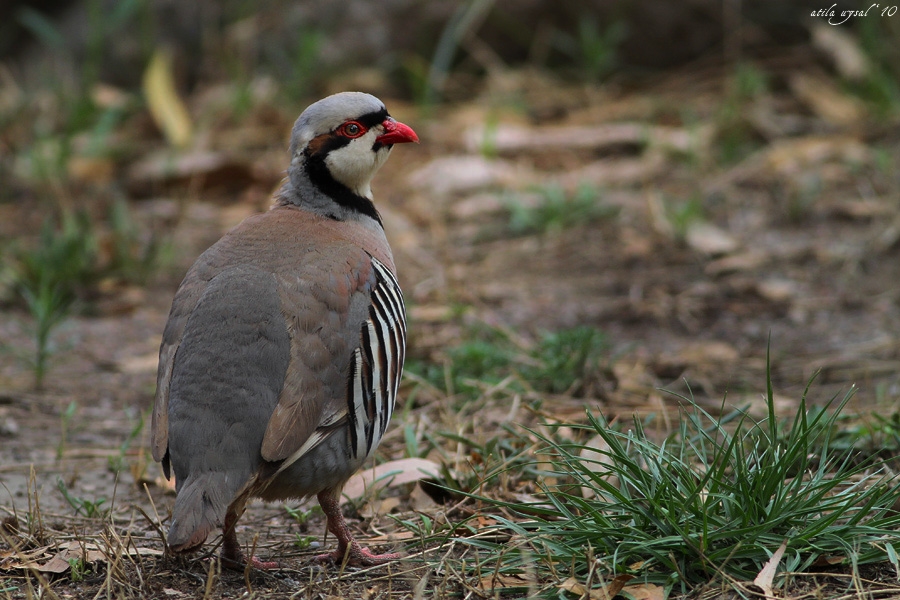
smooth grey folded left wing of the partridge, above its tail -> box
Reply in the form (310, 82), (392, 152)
(168, 266), (291, 487)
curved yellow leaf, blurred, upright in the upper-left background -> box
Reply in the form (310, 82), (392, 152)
(143, 50), (193, 148)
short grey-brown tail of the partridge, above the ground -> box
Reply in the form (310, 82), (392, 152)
(167, 473), (233, 552)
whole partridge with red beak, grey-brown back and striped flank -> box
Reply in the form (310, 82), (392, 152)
(151, 92), (418, 569)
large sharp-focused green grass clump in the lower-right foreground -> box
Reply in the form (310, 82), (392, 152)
(458, 352), (900, 597)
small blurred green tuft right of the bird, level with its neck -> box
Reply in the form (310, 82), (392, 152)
(506, 183), (619, 235)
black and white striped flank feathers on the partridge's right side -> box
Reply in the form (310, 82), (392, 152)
(347, 257), (406, 459)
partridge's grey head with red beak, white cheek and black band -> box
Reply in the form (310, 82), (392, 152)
(289, 92), (419, 218)
